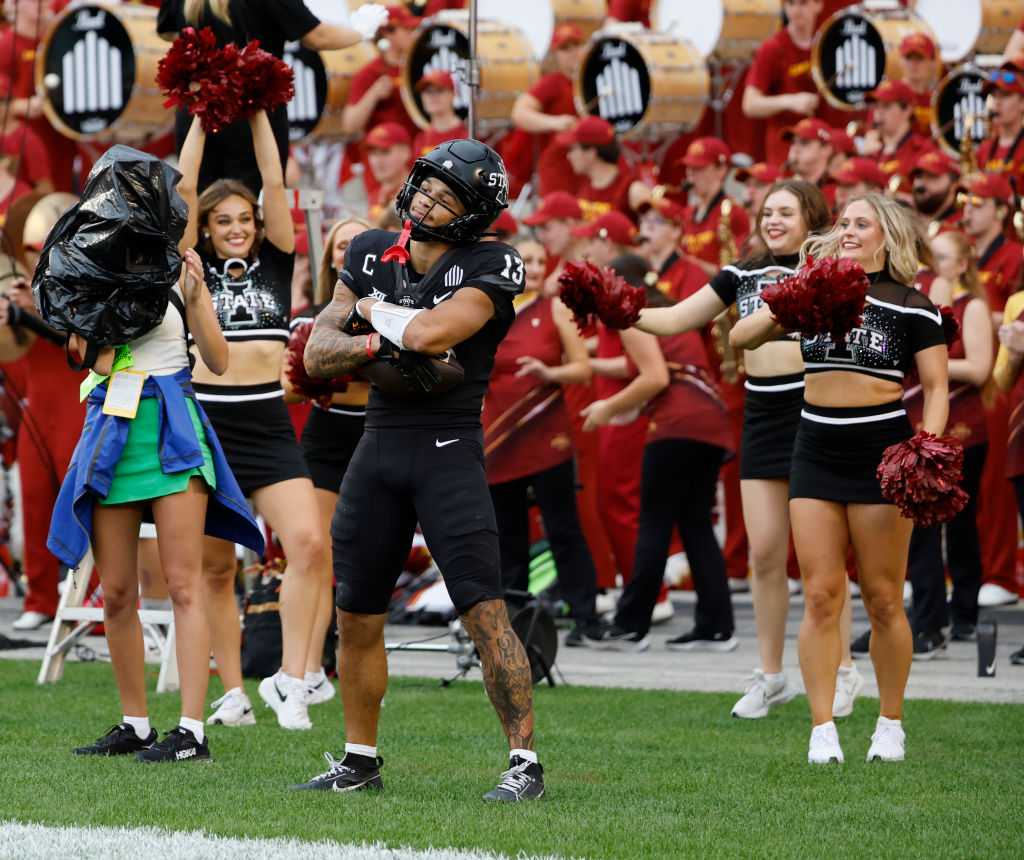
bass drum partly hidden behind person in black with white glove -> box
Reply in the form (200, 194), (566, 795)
(284, 42), (376, 143)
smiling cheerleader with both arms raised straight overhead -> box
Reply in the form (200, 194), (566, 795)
(180, 112), (331, 729)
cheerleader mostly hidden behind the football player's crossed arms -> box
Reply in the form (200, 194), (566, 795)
(282, 212), (370, 704)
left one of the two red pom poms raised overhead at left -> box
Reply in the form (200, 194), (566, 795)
(157, 27), (241, 132)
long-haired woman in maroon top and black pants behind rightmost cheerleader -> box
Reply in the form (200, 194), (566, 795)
(903, 230), (994, 660)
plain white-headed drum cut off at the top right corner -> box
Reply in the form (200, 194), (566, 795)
(913, 0), (1024, 62)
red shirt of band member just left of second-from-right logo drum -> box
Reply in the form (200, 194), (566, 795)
(746, 28), (856, 166)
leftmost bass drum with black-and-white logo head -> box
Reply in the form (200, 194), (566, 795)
(36, 3), (174, 144)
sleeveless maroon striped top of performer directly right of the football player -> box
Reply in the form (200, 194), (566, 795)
(482, 297), (572, 484)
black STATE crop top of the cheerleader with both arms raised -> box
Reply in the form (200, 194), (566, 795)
(200, 239), (295, 343)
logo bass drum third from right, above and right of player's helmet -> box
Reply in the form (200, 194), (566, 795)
(577, 25), (710, 139)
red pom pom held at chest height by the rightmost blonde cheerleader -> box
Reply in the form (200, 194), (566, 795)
(761, 257), (870, 343)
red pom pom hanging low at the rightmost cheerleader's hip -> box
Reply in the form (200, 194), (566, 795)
(877, 430), (968, 526)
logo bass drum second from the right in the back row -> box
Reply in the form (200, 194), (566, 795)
(811, 6), (938, 111)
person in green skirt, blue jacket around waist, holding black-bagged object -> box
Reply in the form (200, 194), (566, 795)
(47, 154), (263, 763)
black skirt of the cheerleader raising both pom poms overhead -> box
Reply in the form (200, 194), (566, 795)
(195, 382), (309, 496)
